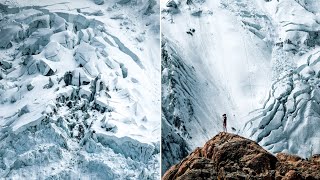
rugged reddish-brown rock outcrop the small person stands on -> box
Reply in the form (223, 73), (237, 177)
(162, 133), (320, 180)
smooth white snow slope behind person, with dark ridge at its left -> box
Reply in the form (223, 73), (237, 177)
(161, 1), (275, 173)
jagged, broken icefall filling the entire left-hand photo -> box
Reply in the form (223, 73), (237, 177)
(0, 0), (160, 179)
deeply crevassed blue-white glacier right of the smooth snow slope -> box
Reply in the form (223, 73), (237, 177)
(244, 0), (320, 158)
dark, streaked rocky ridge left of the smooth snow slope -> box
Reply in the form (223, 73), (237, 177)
(161, 39), (196, 173)
